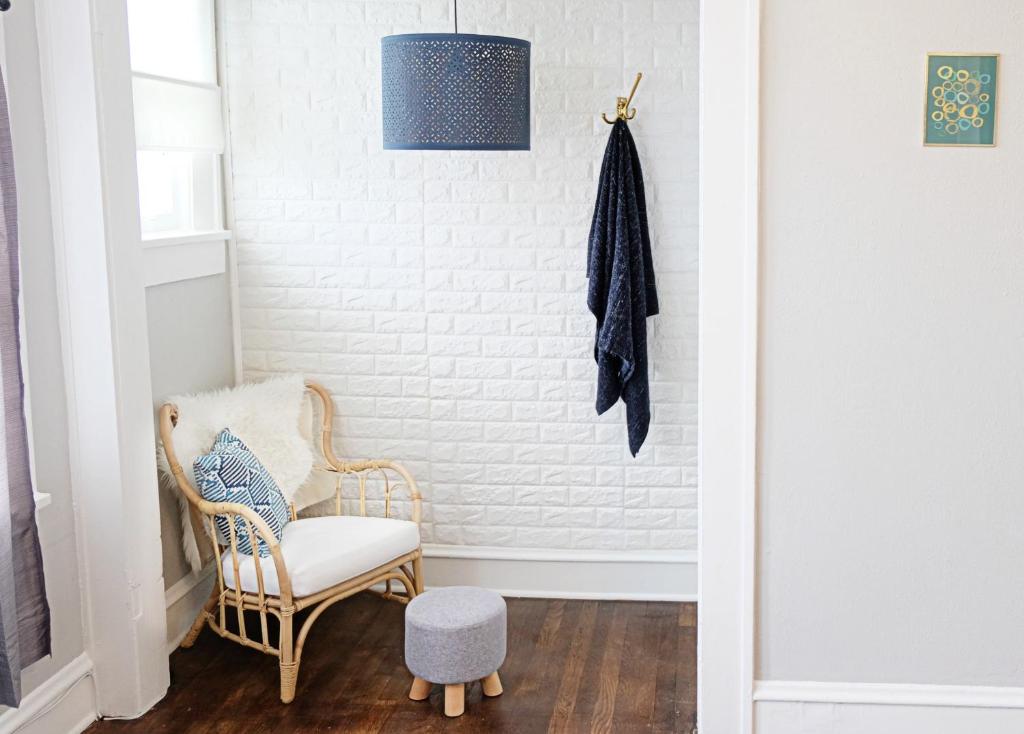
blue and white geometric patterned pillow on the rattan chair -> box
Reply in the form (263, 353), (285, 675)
(193, 428), (289, 556)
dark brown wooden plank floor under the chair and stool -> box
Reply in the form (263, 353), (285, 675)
(87, 594), (696, 734)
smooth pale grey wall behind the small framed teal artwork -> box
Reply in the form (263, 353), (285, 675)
(757, 0), (1024, 700)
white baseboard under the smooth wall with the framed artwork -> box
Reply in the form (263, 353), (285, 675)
(754, 681), (1024, 734)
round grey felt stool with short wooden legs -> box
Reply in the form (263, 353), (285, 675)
(406, 587), (506, 717)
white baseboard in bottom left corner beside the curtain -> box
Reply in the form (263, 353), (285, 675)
(0, 653), (97, 734)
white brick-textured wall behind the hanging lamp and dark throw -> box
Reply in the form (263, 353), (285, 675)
(225, 0), (697, 550)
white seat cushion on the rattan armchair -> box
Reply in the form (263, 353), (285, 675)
(221, 515), (420, 597)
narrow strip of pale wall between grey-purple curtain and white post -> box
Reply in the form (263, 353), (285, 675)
(0, 3), (84, 704)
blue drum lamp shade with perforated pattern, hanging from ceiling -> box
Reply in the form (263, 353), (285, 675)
(381, 33), (529, 150)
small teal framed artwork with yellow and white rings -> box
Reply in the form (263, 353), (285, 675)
(925, 53), (999, 146)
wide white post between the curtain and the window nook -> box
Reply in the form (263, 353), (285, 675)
(35, 0), (170, 716)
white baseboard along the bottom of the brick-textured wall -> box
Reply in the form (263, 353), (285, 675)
(415, 545), (697, 602)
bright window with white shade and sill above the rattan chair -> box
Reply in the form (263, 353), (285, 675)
(128, 0), (229, 285)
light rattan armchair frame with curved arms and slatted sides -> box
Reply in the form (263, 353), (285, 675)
(160, 382), (423, 703)
